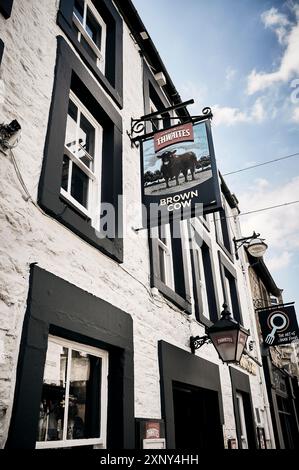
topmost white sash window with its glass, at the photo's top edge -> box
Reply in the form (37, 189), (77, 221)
(73, 0), (107, 73)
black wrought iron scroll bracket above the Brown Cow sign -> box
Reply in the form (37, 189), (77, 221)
(127, 100), (213, 147)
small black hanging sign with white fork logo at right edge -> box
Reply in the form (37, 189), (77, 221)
(258, 304), (299, 346)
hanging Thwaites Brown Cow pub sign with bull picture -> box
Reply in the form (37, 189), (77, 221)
(141, 119), (221, 227)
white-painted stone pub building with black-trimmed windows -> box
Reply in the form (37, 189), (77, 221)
(0, 0), (275, 449)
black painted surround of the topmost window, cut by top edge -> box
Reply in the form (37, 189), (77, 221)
(57, 0), (123, 108)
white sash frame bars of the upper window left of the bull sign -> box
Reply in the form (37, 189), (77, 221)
(60, 91), (103, 228)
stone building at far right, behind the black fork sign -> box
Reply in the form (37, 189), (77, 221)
(247, 254), (299, 449)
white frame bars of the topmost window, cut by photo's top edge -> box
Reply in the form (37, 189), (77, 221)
(73, 0), (107, 73)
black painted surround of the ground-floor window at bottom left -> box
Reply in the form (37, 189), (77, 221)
(6, 265), (135, 449)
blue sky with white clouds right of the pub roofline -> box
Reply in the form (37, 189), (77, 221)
(133, 0), (299, 313)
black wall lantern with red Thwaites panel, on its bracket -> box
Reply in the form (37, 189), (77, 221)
(190, 304), (250, 363)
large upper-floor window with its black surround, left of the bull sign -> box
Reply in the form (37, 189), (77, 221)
(39, 37), (123, 262)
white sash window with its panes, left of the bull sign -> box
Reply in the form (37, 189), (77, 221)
(60, 92), (103, 226)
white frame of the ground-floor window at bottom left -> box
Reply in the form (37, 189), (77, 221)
(35, 335), (108, 449)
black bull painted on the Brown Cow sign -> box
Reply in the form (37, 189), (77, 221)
(157, 150), (197, 188)
